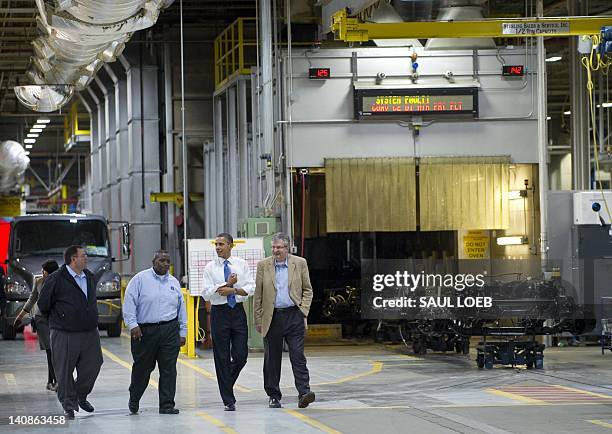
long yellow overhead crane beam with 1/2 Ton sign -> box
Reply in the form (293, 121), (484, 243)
(331, 10), (612, 42)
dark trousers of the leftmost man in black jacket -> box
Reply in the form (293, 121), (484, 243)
(51, 328), (102, 411)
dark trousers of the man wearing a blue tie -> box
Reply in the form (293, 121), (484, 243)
(210, 303), (249, 405)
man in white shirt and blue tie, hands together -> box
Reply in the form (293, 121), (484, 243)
(202, 233), (255, 411)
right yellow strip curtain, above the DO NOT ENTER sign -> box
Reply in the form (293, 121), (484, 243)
(419, 157), (510, 231)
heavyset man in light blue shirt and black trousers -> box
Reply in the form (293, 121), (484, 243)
(123, 250), (187, 414)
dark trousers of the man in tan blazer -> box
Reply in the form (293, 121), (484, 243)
(264, 307), (310, 400)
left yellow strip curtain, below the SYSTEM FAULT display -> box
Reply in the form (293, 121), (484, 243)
(325, 158), (416, 232)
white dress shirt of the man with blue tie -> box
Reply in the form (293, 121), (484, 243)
(201, 256), (255, 304)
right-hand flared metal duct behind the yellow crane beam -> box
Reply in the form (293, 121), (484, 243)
(425, 0), (495, 50)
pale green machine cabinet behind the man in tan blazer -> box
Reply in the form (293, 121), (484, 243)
(239, 217), (277, 349)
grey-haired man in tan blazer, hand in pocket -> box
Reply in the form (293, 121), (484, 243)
(253, 233), (315, 408)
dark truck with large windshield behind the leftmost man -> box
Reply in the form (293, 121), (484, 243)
(0, 214), (129, 339)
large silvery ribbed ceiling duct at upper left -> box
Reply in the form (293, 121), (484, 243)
(15, 0), (173, 111)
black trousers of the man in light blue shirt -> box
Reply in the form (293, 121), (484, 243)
(130, 320), (180, 408)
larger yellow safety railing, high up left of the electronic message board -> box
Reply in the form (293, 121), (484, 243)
(214, 18), (257, 89)
